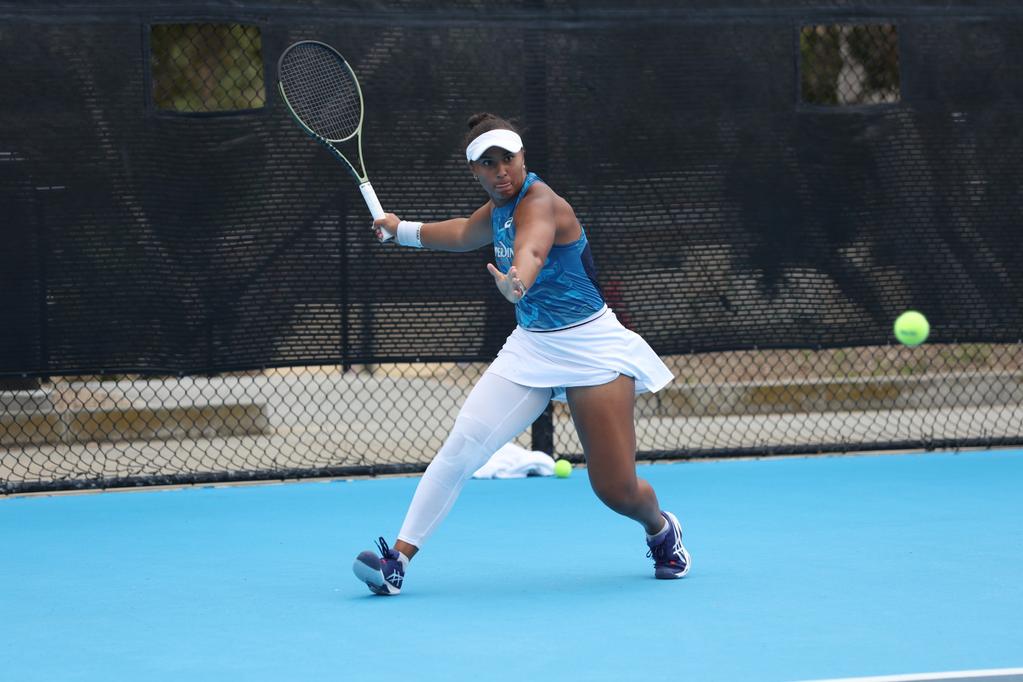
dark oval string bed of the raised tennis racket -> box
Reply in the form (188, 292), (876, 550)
(280, 45), (362, 140)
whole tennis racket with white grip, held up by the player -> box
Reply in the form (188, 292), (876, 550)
(277, 40), (394, 239)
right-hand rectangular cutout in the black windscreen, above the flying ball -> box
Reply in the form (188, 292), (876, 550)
(799, 24), (900, 106)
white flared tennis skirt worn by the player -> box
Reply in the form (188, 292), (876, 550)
(487, 308), (674, 402)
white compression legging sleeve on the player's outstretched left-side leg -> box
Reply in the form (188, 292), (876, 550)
(398, 373), (551, 547)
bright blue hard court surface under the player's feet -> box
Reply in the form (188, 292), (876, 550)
(0, 451), (1023, 681)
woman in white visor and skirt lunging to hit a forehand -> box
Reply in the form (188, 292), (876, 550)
(353, 113), (691, 595)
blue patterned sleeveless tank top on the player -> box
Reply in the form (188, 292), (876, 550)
(490, 173), (604, 331)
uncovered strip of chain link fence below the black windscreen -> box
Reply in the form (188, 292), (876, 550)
(7, 344), (1023, 492)
